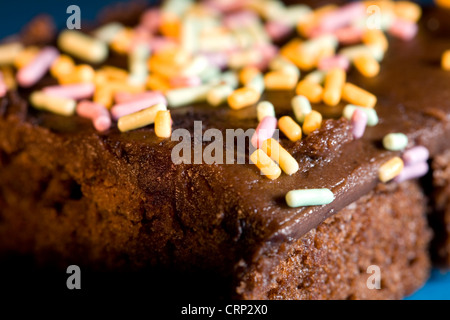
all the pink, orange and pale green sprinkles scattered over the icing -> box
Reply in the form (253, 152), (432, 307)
(0, 0), (432, 207)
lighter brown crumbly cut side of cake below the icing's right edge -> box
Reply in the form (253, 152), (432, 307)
(237, 182), (431, 300)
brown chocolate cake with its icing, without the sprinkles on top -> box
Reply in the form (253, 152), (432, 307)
(0, 0), (450, 299)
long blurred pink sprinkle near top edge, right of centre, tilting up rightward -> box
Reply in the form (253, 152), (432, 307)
(319, 2), (366, 31)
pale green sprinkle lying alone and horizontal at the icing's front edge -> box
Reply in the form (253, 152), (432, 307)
(286, 188), (334, 208)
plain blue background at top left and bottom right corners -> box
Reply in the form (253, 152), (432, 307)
(0, 0), (450, 300)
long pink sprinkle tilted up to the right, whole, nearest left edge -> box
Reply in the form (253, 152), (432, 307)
(17, 47), (59, 87)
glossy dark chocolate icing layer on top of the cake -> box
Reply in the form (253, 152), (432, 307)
(2, 3), (450, 276)
